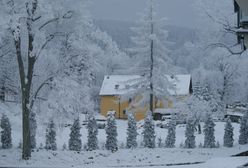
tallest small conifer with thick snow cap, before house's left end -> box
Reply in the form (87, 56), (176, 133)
(105, 112), (118, 152)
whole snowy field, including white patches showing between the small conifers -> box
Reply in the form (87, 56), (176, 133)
(0, 101), (248, 168)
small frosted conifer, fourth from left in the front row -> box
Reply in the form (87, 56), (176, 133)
(68, 118), (82, 151)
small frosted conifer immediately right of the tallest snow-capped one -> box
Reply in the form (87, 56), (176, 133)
(127, 114), (138, 149)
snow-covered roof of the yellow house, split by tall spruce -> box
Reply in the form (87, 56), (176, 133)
(100, 75), (191, 96)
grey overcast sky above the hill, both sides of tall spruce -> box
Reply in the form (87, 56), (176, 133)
(90, 0), (196, 27)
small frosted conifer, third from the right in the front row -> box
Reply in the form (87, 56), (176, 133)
(203, 114), (215, 148)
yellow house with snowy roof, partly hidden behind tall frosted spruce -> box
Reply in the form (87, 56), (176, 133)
(99, 75), (192, 120)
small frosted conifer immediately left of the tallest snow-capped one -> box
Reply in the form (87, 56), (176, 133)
(87, 116), (98, 151)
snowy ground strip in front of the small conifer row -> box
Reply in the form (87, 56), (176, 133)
(0, 145), (248, 168)
